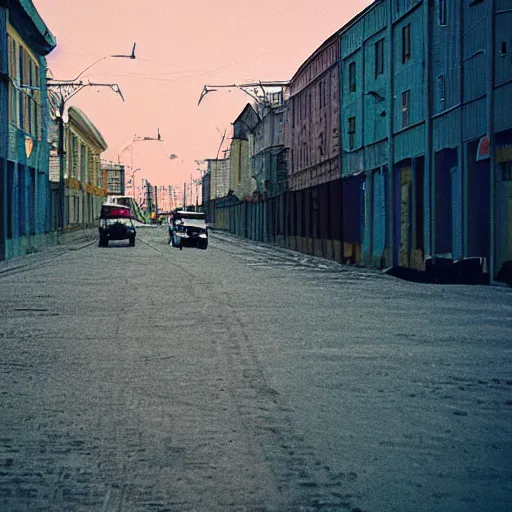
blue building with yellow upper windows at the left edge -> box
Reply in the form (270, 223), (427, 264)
(0, 0), (56, 259)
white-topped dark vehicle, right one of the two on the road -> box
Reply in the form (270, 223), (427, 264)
(169, 210), (208, 250)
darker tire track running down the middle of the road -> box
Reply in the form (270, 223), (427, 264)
(217, 292), (356, 512)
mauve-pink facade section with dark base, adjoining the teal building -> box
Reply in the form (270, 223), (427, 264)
(285, 34), (343, 261)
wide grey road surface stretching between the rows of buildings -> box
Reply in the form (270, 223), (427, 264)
(0, 227), (512, 512)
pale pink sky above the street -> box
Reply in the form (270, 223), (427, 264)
(33, 0), (371, 185)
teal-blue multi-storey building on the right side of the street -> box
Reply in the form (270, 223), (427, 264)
(340, 0), (512, 279)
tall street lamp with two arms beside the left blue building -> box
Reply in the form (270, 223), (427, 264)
(46, 43), (136, 231)
